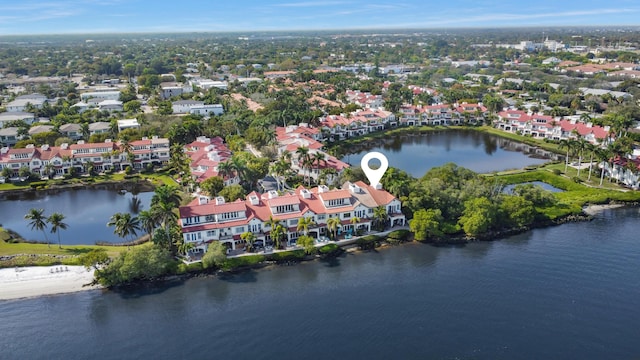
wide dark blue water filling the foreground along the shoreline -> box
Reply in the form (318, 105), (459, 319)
(0, 209), (640, 359)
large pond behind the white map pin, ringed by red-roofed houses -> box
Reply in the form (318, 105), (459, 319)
(342, 130), (547, 177)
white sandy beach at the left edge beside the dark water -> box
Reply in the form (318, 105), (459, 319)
(0, 265), (100, 300)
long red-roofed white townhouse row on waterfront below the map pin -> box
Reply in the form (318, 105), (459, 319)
(179, 181), (406, 253)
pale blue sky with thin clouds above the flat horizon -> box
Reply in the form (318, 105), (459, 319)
(0, 0), (640, 35)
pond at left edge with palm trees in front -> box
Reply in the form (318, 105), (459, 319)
(0, 189), (153, 245)
